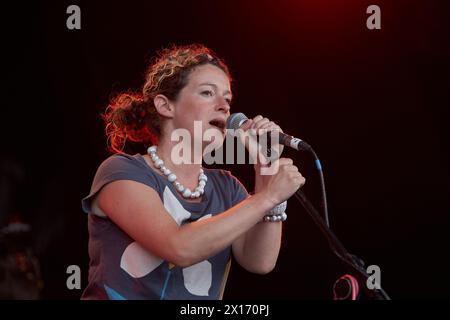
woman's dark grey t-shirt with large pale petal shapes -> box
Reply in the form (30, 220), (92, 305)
(81, 154), (248, 300)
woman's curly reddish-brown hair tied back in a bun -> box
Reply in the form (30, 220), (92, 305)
(102, 44), (232, 153)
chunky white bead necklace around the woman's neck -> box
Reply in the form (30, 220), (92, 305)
(147, 146), (208, 199)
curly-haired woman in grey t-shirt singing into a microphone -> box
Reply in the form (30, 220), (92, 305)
(82, 45), (305, 299)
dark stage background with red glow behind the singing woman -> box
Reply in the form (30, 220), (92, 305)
(1, 0), (450, 299)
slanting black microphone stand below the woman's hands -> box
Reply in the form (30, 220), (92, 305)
(294, 189), (391, 300)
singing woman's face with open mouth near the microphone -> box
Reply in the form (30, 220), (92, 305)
(172, 64), (232, 146)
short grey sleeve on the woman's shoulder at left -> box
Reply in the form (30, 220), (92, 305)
(81, 154), (157, 213)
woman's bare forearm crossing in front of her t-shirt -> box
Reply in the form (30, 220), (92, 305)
(172, 193), (273, 266)
